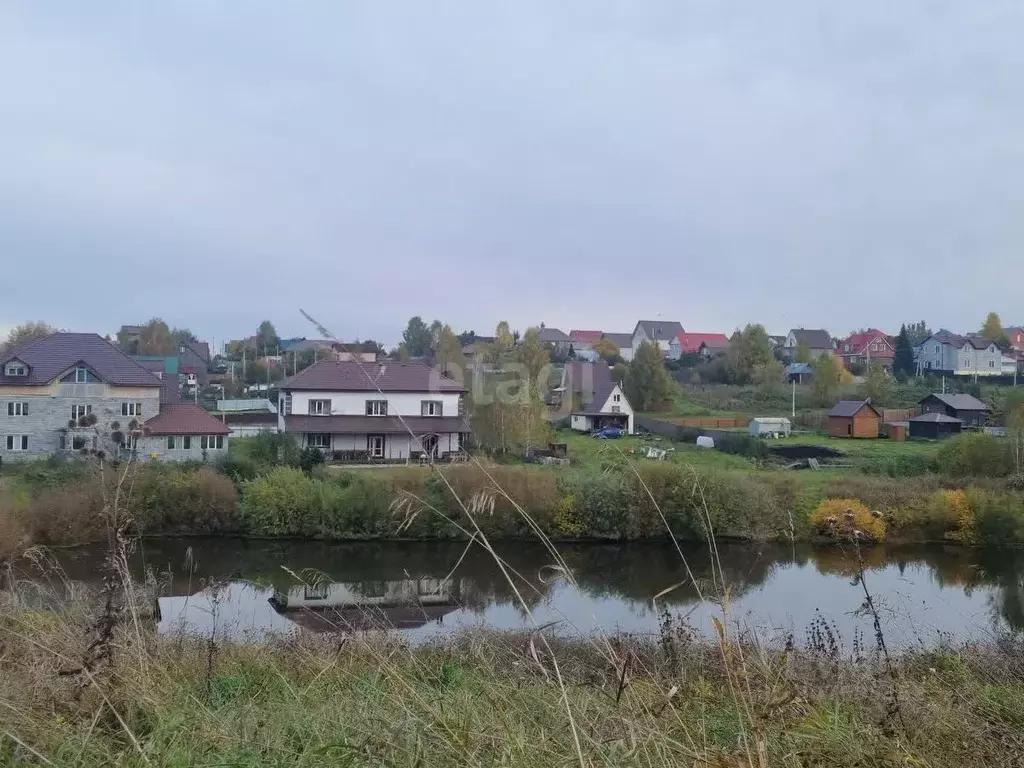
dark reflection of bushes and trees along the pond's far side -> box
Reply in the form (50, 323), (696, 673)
(22, 539), (1024, 630)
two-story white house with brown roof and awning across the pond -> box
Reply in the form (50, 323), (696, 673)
(278, 360), (470, 461)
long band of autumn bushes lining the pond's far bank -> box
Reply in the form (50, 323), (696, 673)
(6, 462), (1024, 555)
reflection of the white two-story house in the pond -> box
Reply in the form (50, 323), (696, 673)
(270, 578), (461, 632)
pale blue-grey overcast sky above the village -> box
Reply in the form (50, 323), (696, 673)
(0, 0), (1024, 343)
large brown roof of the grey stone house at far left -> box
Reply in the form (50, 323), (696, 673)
(0, 332), (161, 387)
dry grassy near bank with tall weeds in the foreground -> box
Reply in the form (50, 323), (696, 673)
(0, 603), (1024, 768)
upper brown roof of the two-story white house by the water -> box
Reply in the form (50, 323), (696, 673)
(281, 360), (466, 392)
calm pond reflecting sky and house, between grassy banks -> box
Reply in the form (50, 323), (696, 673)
(18, 539), (1024, 649)
